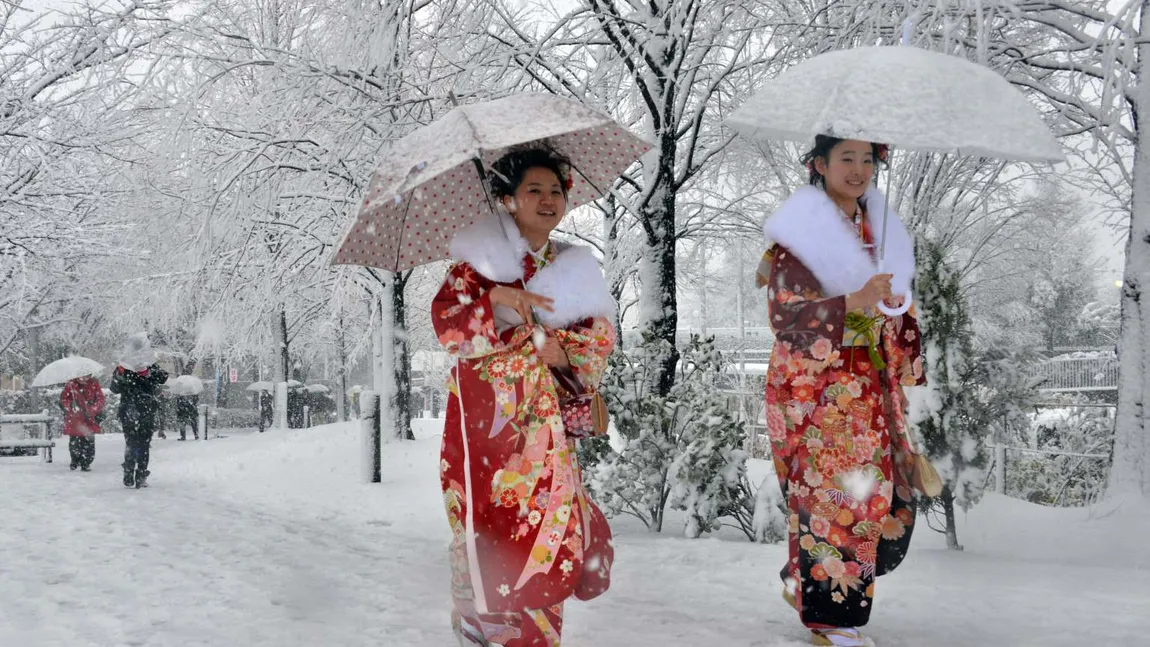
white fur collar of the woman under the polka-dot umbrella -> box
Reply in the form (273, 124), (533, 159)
(451, 214), (618, 332)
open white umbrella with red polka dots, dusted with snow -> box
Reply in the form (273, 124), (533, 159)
(332, 94), (651, 271)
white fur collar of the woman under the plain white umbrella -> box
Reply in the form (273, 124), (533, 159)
(762, 185), (914, 296)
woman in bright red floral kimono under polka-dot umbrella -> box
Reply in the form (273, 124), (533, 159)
(431, 151), (615, 647)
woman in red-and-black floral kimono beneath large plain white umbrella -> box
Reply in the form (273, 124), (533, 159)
(760, 136), (925, 646)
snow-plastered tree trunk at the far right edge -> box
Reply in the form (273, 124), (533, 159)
(1107, 0), (1150, 498)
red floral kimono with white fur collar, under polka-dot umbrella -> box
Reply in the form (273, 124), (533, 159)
(431, 213), (615, 613)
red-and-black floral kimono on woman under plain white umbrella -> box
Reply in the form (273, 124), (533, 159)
(766, 187), (925, 629)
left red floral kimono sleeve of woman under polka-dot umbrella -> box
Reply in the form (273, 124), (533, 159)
(431, 263), (503, 360)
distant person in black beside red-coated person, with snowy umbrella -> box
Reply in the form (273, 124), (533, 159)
(109, 332), (168, 490)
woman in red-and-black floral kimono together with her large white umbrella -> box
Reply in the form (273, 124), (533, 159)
(728, 44), (1063, 647)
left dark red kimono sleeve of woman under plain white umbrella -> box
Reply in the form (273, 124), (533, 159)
(767, 247), (846, 351)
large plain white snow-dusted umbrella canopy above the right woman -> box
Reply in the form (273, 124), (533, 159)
(727, 46), (1065, 162)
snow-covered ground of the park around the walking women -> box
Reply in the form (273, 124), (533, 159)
(0, 421), (1150, 647)
